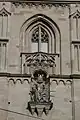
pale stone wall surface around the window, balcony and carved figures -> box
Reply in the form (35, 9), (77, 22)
(0, 0), (80, 120)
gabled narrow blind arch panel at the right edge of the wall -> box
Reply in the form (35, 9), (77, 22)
(70, 10), (80, 72)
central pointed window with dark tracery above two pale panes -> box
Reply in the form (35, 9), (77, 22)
(31, 25), (49, 52)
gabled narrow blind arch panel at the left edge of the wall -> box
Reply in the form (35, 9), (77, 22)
(0, 7), (11, 72)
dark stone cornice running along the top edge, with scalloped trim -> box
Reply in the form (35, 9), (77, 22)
(3, 0), (80, 8)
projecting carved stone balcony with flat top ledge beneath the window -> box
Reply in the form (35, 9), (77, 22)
(21, 52), (59, 74)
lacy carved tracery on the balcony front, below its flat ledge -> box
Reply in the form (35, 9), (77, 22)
(25, 52), (55, 70)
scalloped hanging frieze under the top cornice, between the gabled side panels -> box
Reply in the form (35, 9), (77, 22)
(12, 1), (69, 9)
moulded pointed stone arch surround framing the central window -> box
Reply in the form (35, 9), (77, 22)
(20, 14), (61, 53)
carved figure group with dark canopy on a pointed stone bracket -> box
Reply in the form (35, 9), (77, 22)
(28, 69), (53, 116)
